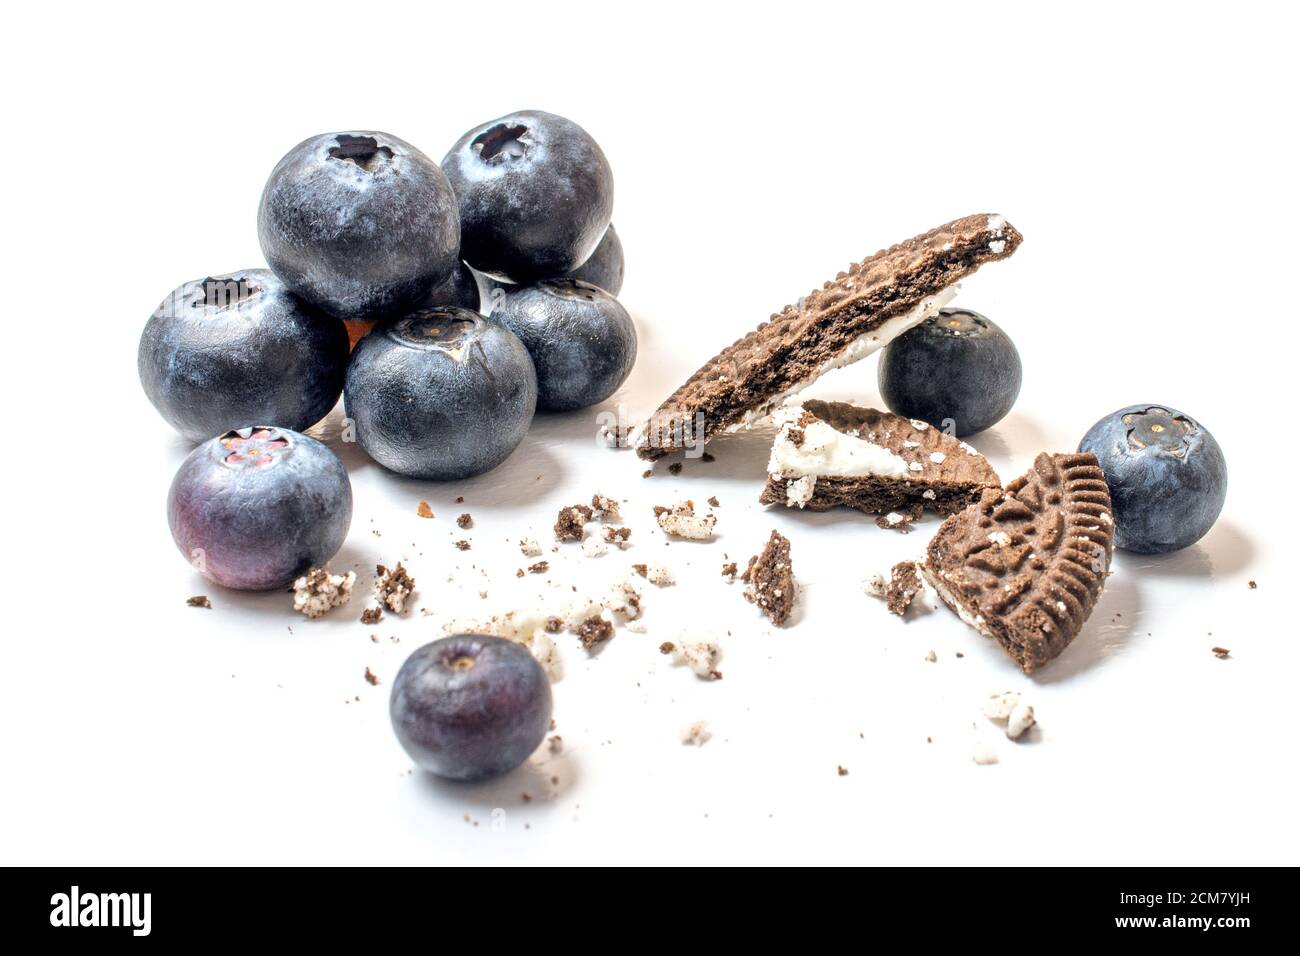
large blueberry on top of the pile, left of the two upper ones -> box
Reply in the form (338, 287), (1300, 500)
(257, 133), (460, 319)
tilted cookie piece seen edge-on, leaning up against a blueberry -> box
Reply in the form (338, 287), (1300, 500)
(633, 213), (1021, 460)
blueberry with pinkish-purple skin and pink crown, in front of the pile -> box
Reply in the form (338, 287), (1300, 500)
(166, 425), (352, 591)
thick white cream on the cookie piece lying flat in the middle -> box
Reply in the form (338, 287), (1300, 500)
(767, 405), (907, 478)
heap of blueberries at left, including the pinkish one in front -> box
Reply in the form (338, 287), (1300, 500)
(139, 111), (637, 589)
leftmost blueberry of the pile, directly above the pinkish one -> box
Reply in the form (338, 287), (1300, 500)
(138, 269), (347, 442)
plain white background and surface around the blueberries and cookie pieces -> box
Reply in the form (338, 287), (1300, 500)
(0, 1), (1300, 865)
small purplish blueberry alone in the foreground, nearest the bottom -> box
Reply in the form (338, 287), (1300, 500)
(389, 633), (551, 780)
